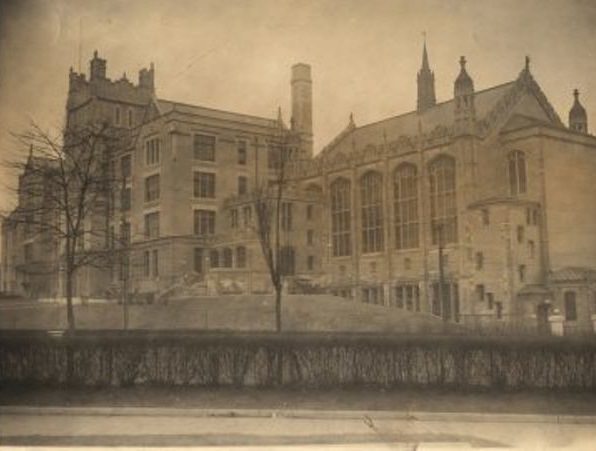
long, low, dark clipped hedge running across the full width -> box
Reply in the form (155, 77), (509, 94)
(0, 332), (596, 391)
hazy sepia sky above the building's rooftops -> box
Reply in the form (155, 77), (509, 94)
(0, 0), (596, 211)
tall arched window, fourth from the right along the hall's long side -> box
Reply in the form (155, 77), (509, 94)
(330, 179), (352, 257)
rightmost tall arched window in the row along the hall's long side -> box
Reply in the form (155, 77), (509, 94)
(428, 155), (457, 244)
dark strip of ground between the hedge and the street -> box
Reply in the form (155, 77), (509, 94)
(0, 387), (596, 421)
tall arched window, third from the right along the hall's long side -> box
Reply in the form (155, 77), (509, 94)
(360, 172), (383, 253)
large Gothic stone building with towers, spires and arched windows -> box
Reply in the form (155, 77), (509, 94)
(3, 47), (596, 331)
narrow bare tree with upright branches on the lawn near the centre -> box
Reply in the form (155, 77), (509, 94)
(253, 127), (296, 333)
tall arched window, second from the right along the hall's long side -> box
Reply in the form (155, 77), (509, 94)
(393, 164), (418, 249)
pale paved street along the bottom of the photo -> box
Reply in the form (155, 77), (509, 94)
(0, 406), (596, 450)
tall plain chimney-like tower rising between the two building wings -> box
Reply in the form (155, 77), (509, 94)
(290, 63), (313, 157)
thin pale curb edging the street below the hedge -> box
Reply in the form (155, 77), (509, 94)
(0, 406), (596, 424)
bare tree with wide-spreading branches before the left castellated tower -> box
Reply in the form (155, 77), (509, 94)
(6, 123), (123, 331)
